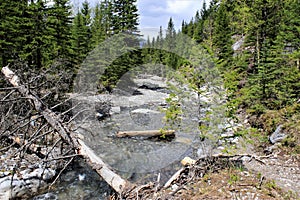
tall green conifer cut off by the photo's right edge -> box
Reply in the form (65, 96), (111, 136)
(271, 0), (300, 107)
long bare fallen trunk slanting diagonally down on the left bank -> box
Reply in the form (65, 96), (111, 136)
(1, 66), (131, 194)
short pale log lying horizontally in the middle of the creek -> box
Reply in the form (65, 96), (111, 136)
(116, 130), (175, 137)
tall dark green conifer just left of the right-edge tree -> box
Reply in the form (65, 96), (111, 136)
(241, 0), (283, 113)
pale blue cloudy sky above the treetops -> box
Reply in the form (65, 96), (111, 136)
(72, 0), (210, 38)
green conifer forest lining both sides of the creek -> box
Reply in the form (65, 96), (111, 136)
(0, 0), (300, 155)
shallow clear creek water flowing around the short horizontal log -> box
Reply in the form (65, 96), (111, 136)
(35, 77), (211, 199)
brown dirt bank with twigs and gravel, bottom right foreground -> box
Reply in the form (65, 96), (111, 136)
(112, 143), (300, 200)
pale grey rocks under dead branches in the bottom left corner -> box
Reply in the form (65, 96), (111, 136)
(0, 147), (58, 199)
